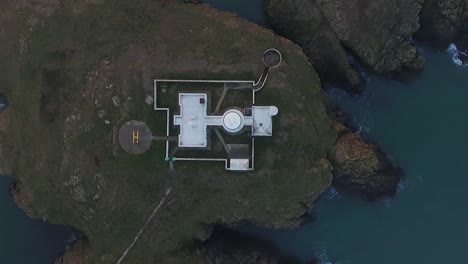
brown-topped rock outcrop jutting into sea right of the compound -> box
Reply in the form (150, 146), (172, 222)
(329, 120), (403, 200)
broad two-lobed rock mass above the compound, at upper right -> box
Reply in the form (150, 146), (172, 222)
(266, 0), (424, 92)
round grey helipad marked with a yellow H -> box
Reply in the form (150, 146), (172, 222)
(119, 120), (153, 154)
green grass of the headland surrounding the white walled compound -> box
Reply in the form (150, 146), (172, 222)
(0, 0), (335, 263)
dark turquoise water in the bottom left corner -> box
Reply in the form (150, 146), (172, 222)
(0, 176), (73, 264)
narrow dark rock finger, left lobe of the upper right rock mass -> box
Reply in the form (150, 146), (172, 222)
(266, 0), (364, 93)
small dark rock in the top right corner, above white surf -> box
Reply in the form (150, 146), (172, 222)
(416, 0), (468, 50)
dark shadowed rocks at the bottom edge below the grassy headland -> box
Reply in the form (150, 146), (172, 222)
(198, 227), (318, 264)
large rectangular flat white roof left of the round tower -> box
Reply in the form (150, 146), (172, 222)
(174, 93), (208, 148)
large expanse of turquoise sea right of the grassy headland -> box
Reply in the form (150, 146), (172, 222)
(202, 0), (468, 264)
